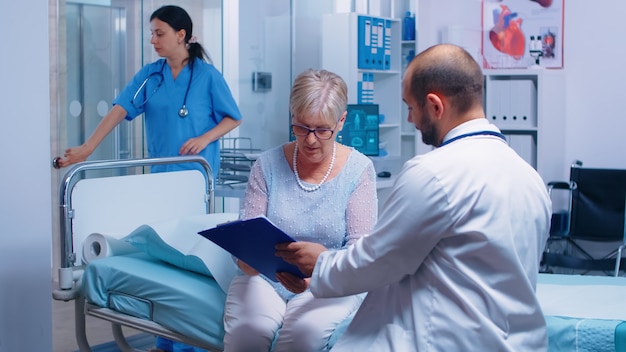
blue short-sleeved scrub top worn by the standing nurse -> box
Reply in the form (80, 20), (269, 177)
(113, 59), (241, 180)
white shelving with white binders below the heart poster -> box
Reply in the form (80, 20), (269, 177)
(484, 69), (565, 182)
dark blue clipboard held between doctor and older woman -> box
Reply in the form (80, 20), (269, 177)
(198, 217), (305, 282)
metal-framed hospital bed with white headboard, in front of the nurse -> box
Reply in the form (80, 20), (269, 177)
(52, 156), (237, 351)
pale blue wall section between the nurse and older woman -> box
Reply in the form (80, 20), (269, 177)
(235, 0), (291, 149)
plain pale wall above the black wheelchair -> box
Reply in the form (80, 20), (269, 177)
(563, 0), (626, 168)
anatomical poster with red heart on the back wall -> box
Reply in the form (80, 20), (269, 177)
(483, 0), (564, 68)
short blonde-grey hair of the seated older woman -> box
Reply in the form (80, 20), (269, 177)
(289, 69), (348, 123)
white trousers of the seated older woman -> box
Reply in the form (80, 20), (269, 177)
(224, 275), (363, 352)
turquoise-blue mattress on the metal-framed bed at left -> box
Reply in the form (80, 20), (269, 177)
(82, 253), (226, 349)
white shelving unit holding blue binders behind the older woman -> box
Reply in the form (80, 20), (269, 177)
(322, 12), (404, 183)
